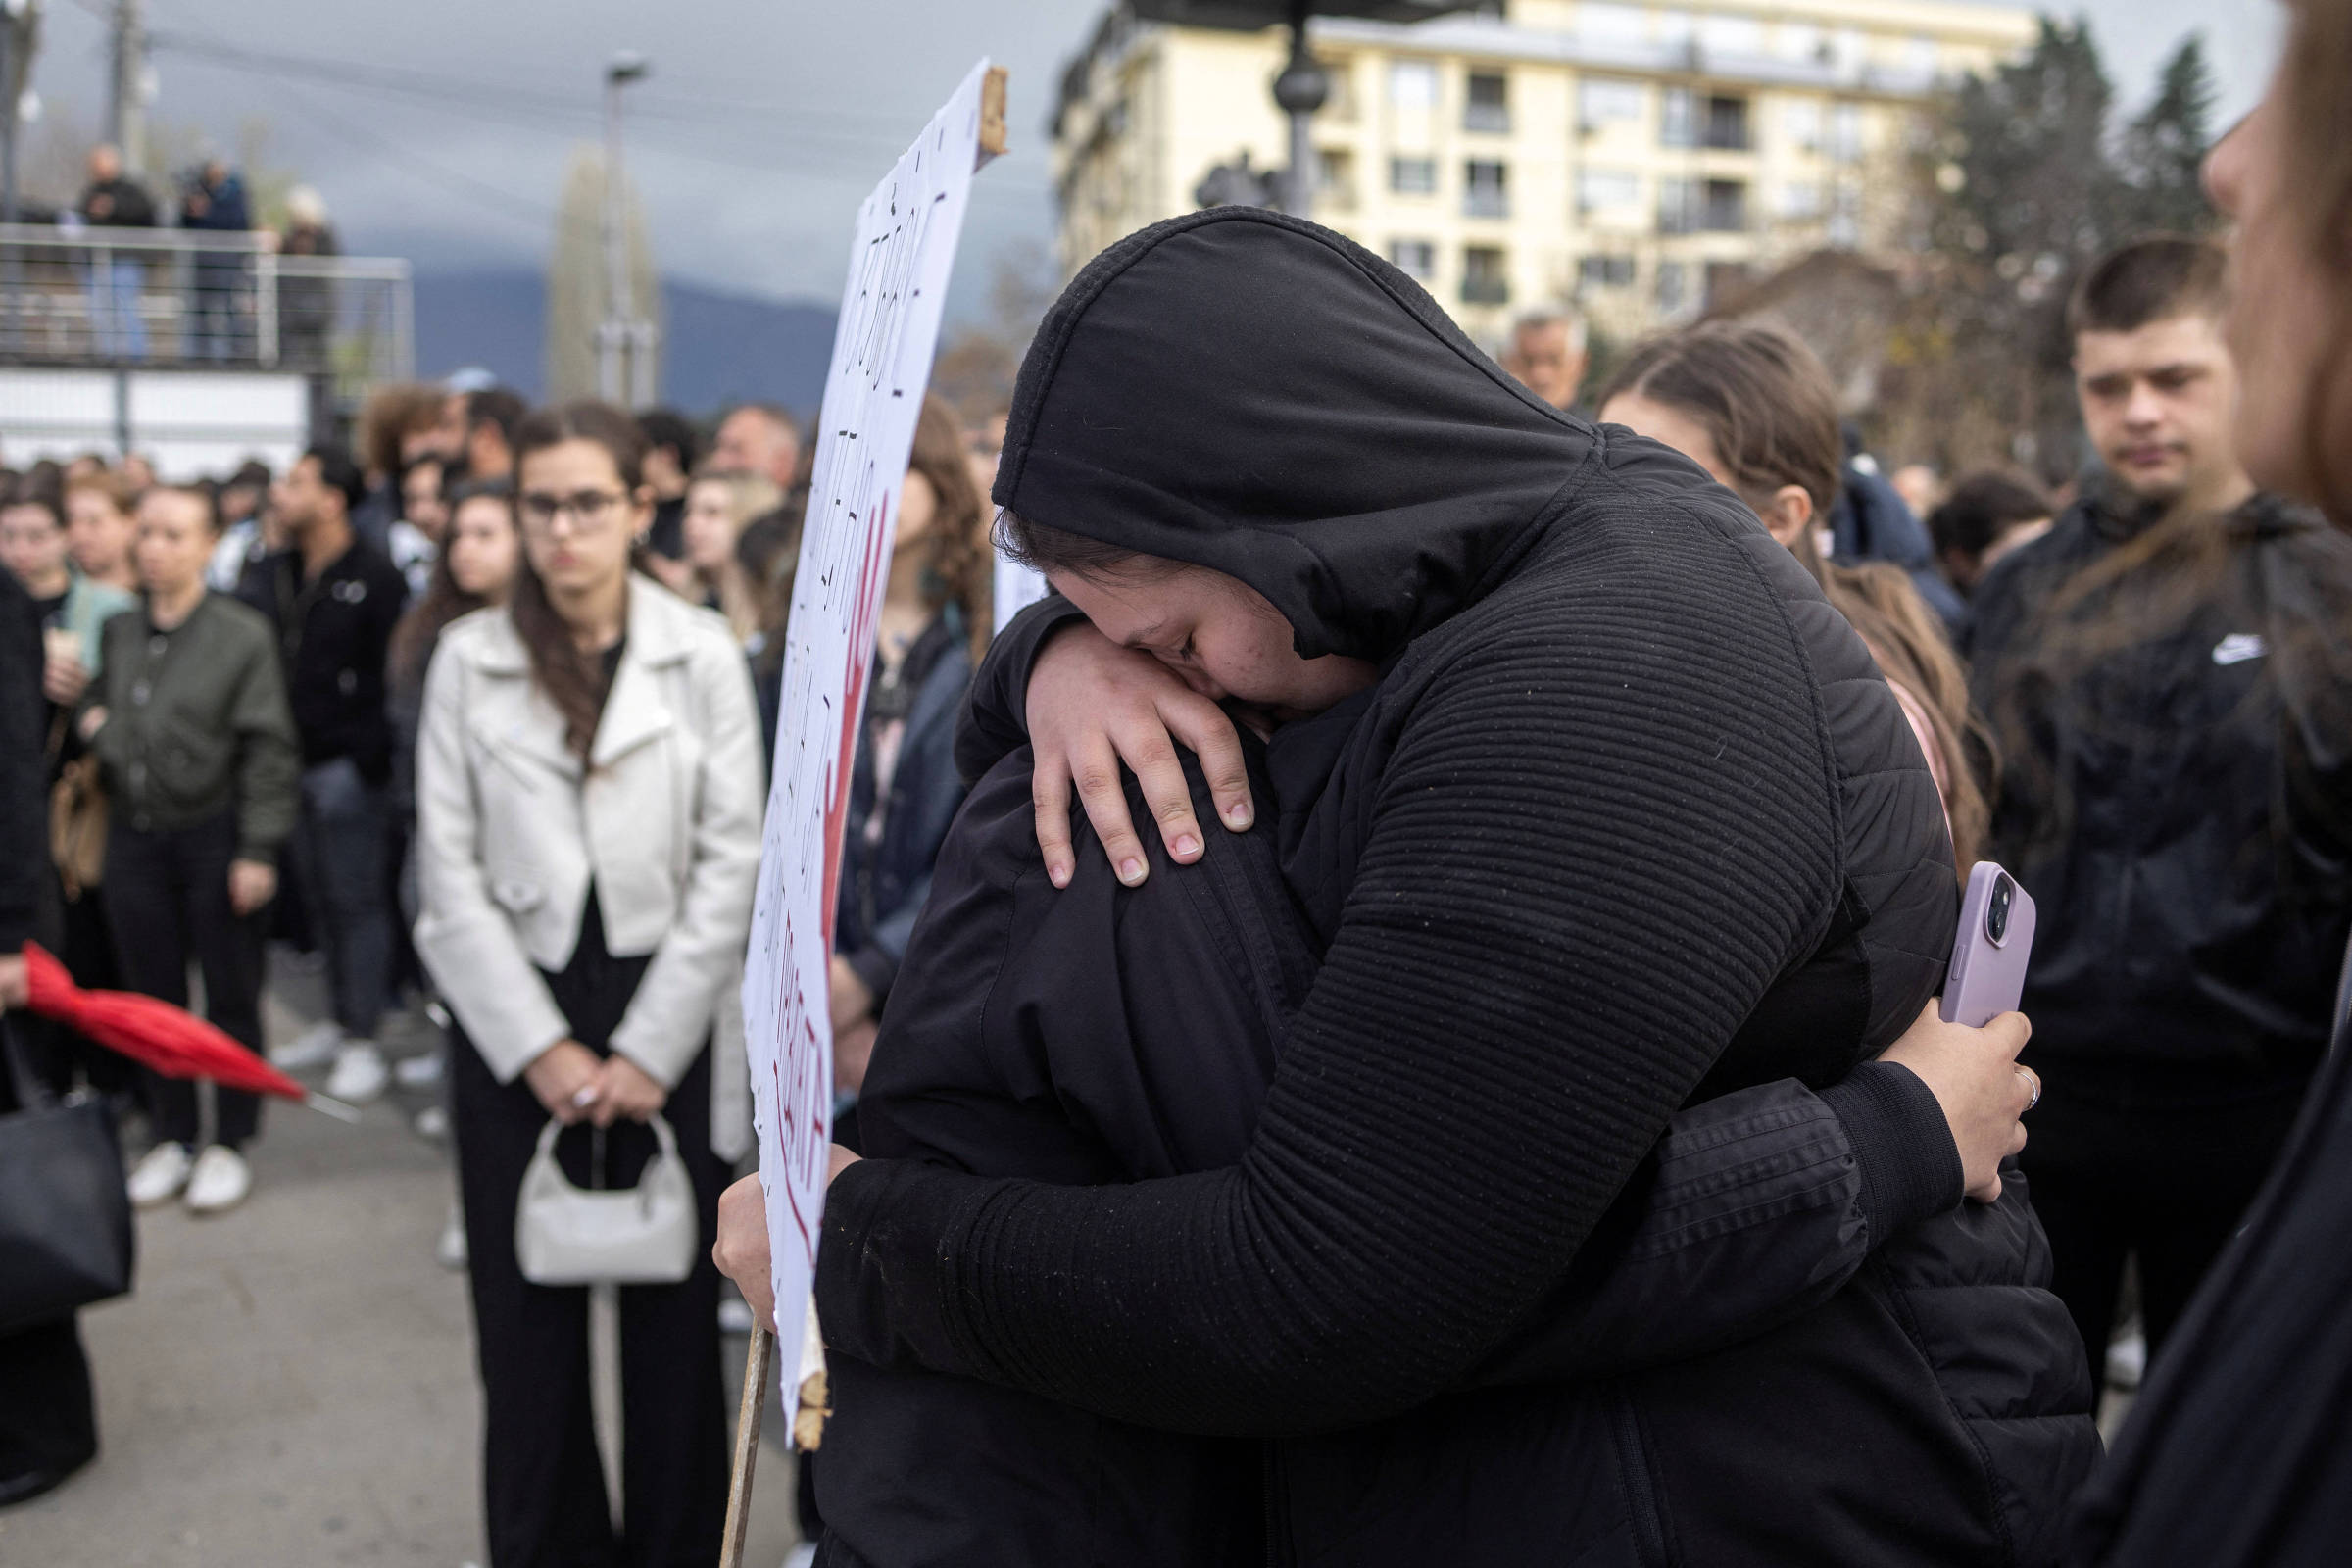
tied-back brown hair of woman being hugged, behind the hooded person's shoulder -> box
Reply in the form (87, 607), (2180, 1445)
(1599, 322), (1994, 874)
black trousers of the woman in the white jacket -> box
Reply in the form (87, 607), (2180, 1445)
(449, 1020), (727, 1568)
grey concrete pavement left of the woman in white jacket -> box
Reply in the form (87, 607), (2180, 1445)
(0, 973), (795, 1568)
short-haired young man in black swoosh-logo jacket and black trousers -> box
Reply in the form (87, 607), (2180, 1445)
(1974, 237), (2352, 1363)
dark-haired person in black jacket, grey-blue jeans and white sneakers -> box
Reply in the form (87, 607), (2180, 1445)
(237, 447), (410, 1102)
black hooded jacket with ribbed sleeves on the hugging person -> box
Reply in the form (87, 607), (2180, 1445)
(818, 209), (2095, 1563)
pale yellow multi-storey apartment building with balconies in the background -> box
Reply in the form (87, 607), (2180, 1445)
(1054, 0), (2039, 343)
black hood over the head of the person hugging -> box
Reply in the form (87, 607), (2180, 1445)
(995, 207), (1597, 661)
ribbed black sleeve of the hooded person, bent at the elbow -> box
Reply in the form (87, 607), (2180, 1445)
(818, 553), (1841, 1432)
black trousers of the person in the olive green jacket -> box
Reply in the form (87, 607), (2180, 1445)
(106, 811), (261, 1148)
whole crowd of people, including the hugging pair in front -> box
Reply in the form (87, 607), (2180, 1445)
(0, 18), (2352, 1568)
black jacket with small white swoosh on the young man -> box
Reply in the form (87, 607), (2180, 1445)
(1971, 496), (2352, 1098)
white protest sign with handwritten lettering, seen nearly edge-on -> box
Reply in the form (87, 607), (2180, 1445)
(743, 59), (988, 1439)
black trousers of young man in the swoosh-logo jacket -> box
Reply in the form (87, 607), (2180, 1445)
(2023, 1055), (2303, 1378)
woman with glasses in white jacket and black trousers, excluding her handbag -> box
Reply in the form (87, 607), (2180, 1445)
(416, 402), (762, 1568)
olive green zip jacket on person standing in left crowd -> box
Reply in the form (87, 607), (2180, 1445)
(82, 592), (301, 865)
